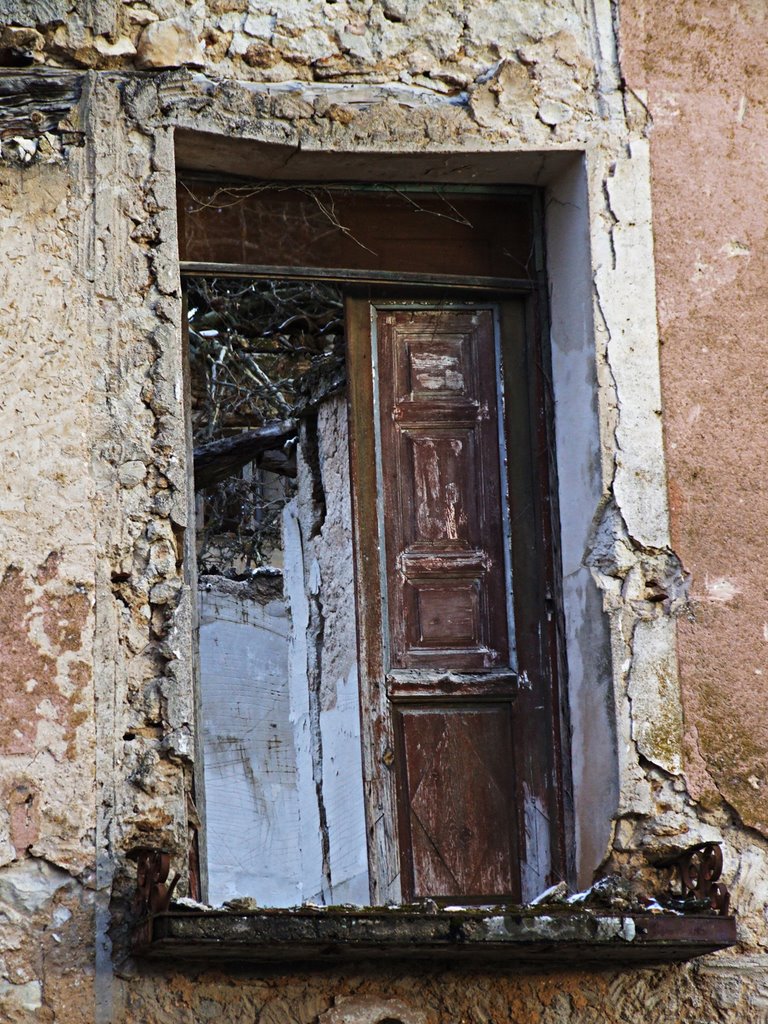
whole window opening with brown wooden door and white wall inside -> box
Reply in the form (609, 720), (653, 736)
(180, 183), (567, 906)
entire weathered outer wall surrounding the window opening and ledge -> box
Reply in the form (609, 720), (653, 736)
(0, 0), (768, 1024)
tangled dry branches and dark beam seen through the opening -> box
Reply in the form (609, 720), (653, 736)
(188, 278), (345, 577)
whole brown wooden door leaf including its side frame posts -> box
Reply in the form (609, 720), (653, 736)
(347, 296), (567, 902)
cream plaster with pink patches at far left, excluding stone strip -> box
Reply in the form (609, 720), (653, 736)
(0, 157), (96, 1021)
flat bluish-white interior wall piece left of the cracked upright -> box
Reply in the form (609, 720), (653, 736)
(200, 577), (300, 906)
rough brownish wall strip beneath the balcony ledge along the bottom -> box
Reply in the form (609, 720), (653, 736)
(118, 957), (768, 1024)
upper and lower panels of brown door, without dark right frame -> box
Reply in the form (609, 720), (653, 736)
(349, 303), (540, 901)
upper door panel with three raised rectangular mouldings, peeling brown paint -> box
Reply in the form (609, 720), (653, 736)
(376, 307), (510, 672)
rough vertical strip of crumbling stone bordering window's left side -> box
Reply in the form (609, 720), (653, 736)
(83, 83), (195, 917)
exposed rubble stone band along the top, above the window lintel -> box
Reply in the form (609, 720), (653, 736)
(4, 0), (594, 112)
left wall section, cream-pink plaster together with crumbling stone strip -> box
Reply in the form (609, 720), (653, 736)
(0, 68), (193, 1021)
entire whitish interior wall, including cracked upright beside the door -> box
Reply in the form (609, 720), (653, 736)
(200, 397), (370, 906)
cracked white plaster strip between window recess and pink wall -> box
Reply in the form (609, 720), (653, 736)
(584, 136), (689, 849)
